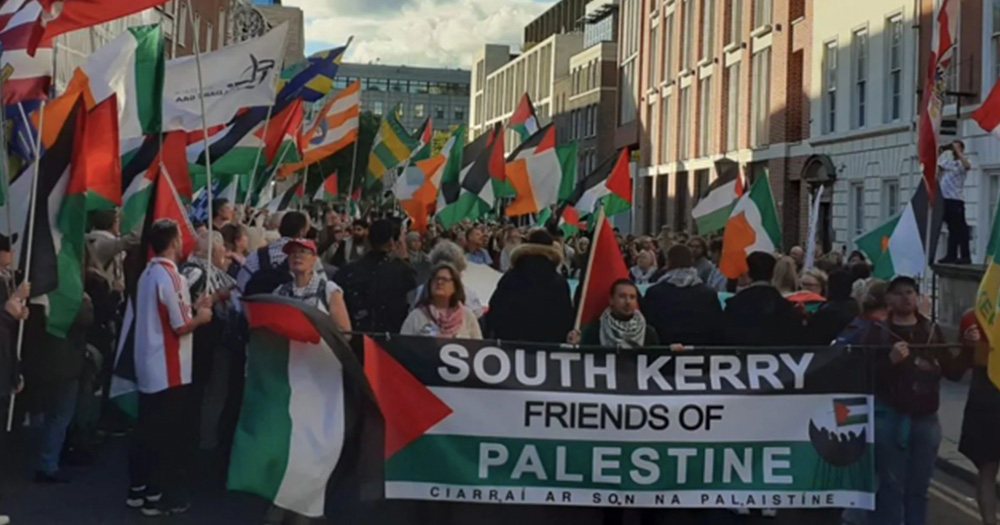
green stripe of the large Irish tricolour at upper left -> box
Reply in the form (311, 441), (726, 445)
(129, 25), (166, 134)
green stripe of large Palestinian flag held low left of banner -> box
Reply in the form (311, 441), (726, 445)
(228, 330), (292, 501)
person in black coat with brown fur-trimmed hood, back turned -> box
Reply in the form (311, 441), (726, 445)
(486, 230), (574, 343)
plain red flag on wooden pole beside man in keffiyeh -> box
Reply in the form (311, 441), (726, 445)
(576, 209), (629, 331)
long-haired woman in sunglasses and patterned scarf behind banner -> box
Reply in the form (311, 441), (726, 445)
(400, 263), (483, 339)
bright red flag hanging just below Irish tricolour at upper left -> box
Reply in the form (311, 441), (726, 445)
(80, 95), (122, 210)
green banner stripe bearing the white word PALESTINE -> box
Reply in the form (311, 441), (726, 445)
(385, 434), (875, 492)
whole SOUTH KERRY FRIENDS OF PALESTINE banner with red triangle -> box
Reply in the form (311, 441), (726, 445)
(365, 336), (875, 509)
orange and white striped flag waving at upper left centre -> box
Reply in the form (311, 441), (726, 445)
(278, 80), (361, 178)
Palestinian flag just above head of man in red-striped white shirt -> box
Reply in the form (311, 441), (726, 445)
(121, 131), (193, 233)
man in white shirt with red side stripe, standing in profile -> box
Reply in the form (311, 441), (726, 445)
(126, 219), (212, 516)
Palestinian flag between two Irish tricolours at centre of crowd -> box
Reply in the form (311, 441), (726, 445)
(437, 124), (504, 228)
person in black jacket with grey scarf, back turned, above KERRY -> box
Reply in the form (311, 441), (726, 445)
(643, 244), (722, 345)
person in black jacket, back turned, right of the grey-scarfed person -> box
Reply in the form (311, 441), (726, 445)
(723, 252), (802, 346)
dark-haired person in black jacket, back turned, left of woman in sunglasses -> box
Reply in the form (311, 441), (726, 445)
(334, 219), (417, 334)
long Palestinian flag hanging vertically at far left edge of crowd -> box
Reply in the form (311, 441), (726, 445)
(19, 102), (87, 338)
